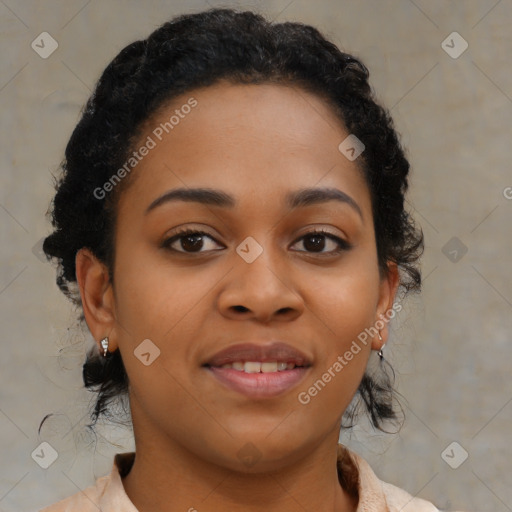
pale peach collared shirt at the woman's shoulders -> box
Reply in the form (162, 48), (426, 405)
(39, 444), (460, 512)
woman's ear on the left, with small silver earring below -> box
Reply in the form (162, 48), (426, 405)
(75, 248), (117, 353)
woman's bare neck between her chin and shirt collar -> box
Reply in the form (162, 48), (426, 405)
(123, 416), (357, 512)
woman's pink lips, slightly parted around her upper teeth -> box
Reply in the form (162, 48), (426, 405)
(203, 342), (311, 398)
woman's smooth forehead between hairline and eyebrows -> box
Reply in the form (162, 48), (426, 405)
(118, 82), (368, 216)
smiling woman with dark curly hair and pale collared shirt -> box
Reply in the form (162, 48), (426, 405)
(38, 9), (460, 512)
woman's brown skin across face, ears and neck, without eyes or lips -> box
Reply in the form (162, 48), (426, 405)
(76, 82), (398, 512)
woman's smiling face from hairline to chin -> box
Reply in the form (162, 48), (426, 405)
(81, 83), (396, 471)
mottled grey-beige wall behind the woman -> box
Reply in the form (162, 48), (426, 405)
(0, 0), (512, 512)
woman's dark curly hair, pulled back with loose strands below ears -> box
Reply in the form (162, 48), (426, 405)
(43, 9), (423, 430)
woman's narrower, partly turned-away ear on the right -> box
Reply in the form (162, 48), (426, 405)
(372, 262), (402, 350)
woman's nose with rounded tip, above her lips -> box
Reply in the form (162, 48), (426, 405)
(218, 242), (304, 323)
